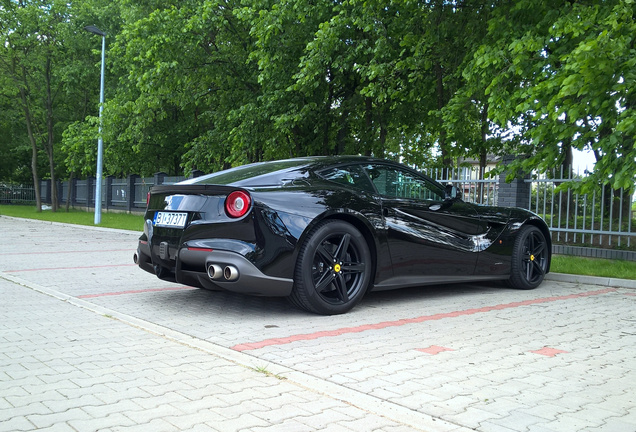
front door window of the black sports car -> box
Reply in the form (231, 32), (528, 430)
(365, 164), (444, 201)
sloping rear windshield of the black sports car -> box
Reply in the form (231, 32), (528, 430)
(180, 159), (308, 186)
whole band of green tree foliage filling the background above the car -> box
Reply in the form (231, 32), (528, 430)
(0, 0), (636, 196)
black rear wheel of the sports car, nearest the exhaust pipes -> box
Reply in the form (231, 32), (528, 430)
(290, 220), (373, 315)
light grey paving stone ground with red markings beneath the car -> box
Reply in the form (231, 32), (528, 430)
(0, 216), (636, 432)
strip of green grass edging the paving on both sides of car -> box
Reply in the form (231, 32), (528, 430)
(0, 205), (636, 279)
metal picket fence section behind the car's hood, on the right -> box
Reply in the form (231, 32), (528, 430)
(426, 164), (636, 249)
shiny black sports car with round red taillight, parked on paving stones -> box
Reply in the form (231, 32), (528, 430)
(135, 156), (551, 315)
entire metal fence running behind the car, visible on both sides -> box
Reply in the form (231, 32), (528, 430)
(0, 167), (636, 253)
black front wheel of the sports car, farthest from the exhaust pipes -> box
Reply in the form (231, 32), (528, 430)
(508, 225), (550, 290)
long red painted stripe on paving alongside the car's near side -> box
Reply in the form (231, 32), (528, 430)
(231, 288), (616, 351)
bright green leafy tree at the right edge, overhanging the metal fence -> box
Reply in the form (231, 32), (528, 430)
(466, 0), (636, 189)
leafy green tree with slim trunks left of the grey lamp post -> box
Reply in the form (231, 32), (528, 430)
(0, 0), (107, 211)
